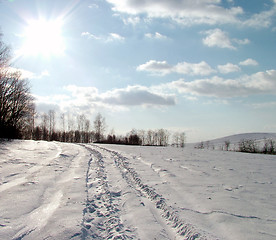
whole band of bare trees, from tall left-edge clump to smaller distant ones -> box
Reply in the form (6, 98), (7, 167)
(0, 30), (186, 147)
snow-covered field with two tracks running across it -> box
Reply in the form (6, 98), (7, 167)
(0, 141), (276, 240)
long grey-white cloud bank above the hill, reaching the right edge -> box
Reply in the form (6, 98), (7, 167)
(164, 70), (276, 98)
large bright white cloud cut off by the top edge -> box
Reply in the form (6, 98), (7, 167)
(104, 0), (243, 25)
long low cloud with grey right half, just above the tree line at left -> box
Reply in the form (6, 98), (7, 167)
(35, 85), (176, 114)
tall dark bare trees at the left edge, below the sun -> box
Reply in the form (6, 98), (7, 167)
(0, 33), (34, 138)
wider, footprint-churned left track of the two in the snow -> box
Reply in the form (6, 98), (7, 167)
(81, 146), (134, 239)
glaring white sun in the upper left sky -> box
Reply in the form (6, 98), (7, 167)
(21, 19), (65, 57)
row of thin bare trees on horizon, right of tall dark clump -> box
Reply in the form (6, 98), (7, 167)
(18, 106), (186, 147)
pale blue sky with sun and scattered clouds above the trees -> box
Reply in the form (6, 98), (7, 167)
(0, 0), (276, 142)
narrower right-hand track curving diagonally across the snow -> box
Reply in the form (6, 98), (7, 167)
(97, 146), (217, 240)
